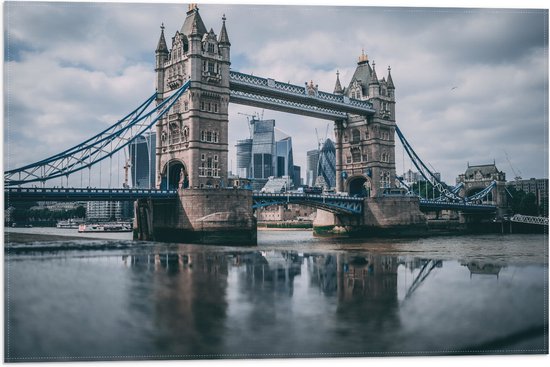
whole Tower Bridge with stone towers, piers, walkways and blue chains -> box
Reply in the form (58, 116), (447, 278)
(4, 5), (504, 244)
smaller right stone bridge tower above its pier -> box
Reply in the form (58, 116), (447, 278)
(334, 52), (395, 197)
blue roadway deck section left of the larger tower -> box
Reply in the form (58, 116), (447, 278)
(4, 187), (178, 202)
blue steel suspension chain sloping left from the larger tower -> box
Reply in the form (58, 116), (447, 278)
(4, 81), (190, 186)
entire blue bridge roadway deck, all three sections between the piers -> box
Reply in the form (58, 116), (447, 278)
(4, 187), (496, 215)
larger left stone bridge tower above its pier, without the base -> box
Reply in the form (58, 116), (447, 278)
(155, 5), (231, 188)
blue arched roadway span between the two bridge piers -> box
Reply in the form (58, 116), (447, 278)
(252, 193), (363, 215)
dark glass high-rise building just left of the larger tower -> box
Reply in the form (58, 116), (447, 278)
(128, 132), (156, 189)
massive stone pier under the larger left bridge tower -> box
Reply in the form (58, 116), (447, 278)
(138, 189), (257, 246)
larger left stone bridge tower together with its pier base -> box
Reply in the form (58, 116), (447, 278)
(134, 4), (256, 245)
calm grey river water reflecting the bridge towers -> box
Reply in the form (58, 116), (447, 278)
(4, 228), (548, 362)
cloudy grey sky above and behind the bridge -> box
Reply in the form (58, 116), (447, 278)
(4, 2), (548, 187)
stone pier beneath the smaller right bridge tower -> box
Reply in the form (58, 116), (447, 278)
(313, 196), (427, 237)
